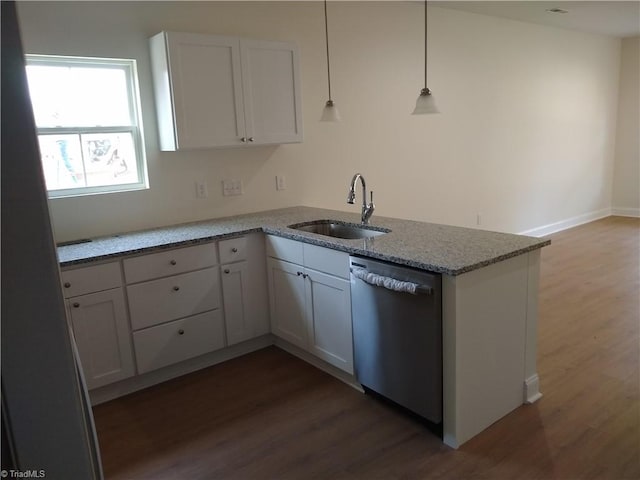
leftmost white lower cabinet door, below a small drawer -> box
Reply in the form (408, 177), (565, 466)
(69, 288), (134, 389)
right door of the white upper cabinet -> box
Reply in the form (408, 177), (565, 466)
(240, 40), (302, 144)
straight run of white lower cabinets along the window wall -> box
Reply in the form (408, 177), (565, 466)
(62, 233), (270, 389)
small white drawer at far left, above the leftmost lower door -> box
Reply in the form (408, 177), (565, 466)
(61, 262), (122, 298)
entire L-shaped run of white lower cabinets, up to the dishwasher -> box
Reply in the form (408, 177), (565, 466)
(62, 233), (353, 396)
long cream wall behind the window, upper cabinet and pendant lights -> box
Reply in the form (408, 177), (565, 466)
(19, 2), (620, 240)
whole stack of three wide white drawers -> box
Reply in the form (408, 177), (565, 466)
(123, 243), (225, 374)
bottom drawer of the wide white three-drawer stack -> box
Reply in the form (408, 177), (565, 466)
(133, 310), (224, 373)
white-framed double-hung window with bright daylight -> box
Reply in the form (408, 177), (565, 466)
(26, 55), (147, 197)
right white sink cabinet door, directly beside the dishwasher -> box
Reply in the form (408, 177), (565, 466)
(305, 269), (353, 373)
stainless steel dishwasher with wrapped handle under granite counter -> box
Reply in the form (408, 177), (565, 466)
(350, 256), (442, 424)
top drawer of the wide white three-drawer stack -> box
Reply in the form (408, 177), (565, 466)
(123, 243), (218, 283)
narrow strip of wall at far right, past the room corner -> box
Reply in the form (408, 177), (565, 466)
(613, 37), (640, 217)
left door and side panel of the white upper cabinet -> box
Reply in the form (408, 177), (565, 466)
(151, 32), (246, 150)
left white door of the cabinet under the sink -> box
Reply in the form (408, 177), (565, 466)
(267, 258), (308, 349)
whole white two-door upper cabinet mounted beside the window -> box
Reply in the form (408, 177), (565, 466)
(150, 32), (302, 150)
